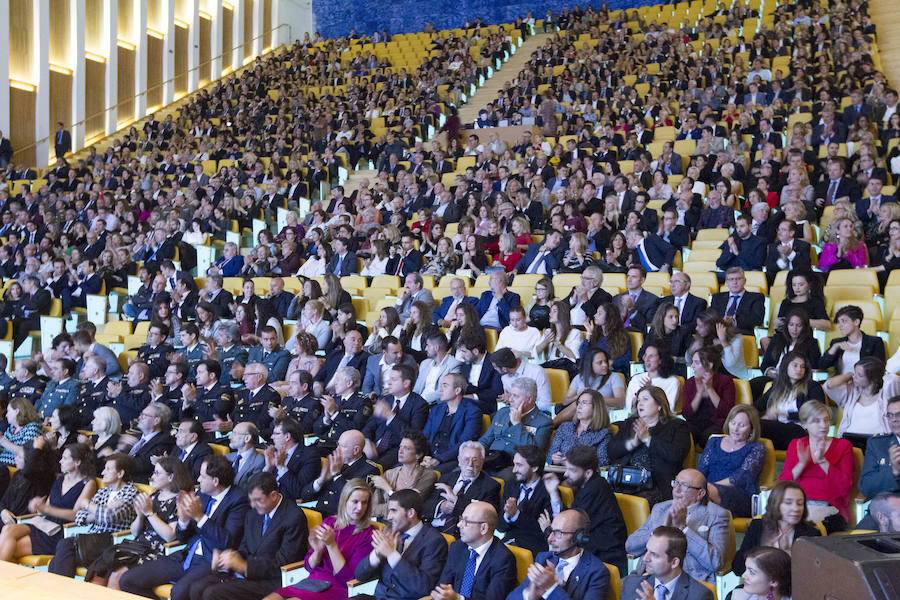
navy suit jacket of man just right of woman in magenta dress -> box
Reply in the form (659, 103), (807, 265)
(356, 523), (447, 600)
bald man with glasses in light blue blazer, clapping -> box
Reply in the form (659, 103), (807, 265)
(625, 469), (731, 584)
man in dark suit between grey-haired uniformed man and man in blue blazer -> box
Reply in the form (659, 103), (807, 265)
(362, 365), (429, 470)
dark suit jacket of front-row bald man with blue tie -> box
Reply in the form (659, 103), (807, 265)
(439, 538), (517, 600)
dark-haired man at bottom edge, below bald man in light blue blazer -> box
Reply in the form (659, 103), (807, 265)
(621, 526), (714, 600)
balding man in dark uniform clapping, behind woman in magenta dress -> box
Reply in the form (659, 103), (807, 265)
(301, 428), (379, 515)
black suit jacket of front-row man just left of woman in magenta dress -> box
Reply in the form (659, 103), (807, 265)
(238, 498), (309, 587)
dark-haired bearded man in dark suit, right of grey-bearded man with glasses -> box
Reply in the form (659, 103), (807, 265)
(497, 446), (553, 555)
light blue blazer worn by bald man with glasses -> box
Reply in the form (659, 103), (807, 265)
(625, 500), (731, 583)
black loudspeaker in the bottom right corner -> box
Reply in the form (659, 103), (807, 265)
(791, 533), (900, 600)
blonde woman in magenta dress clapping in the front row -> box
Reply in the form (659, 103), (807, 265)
(264, 479), (374, 600)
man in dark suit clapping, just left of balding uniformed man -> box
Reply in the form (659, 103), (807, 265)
(264, 418), (321, 501)
